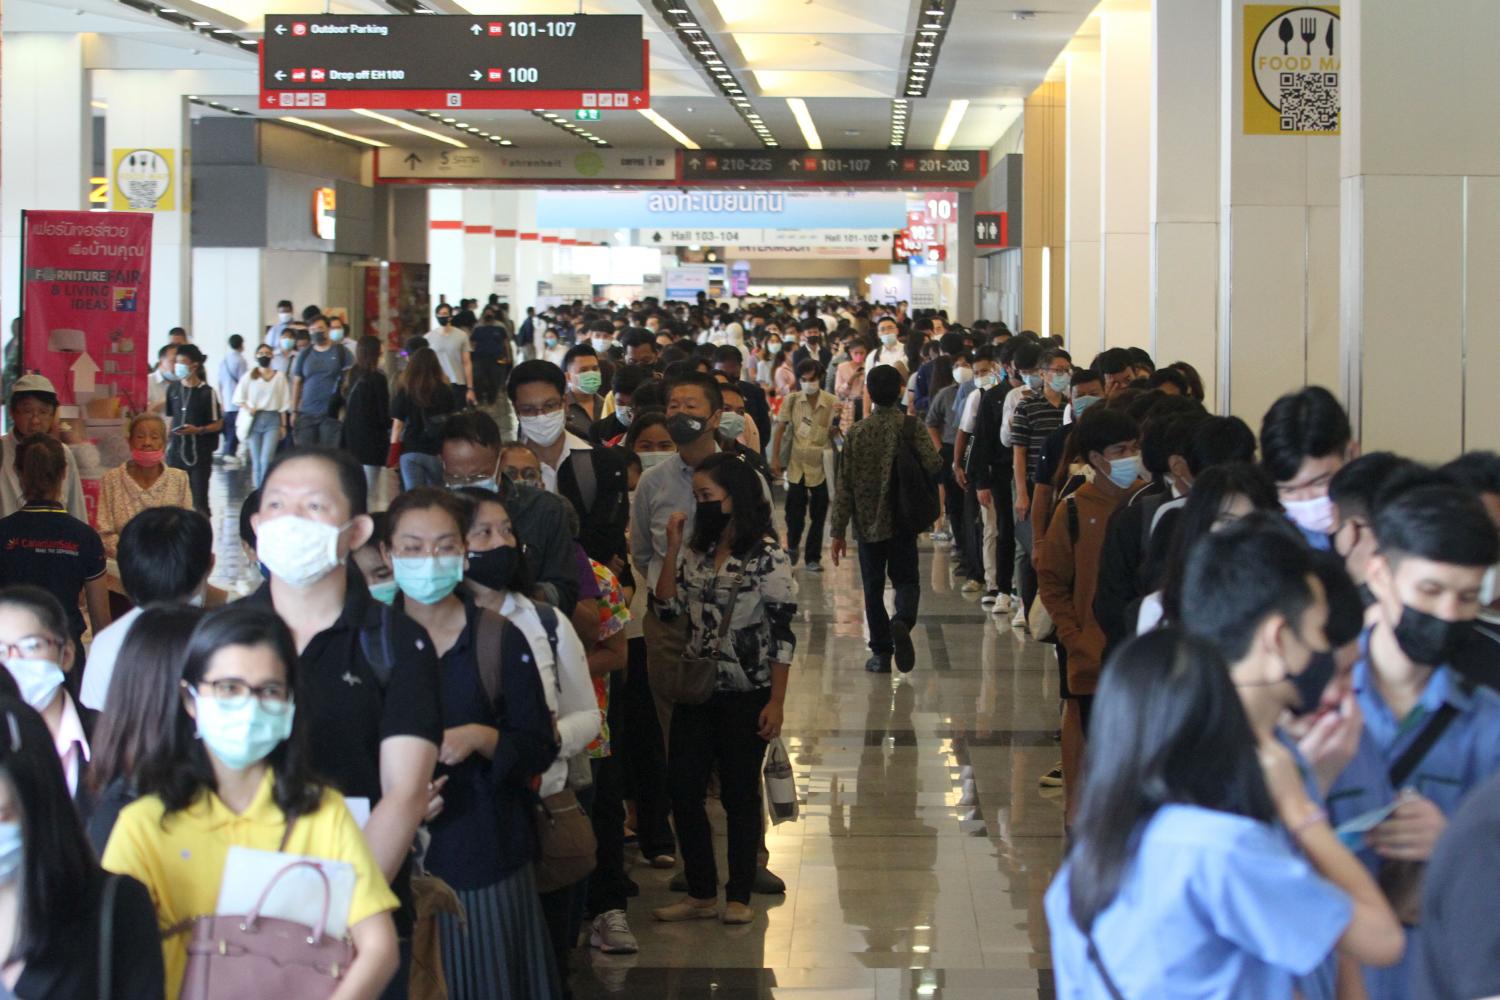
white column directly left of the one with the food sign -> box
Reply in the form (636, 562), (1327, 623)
(1151, 0), (1220, 409)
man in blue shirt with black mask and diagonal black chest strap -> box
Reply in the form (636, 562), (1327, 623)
(1328, 486), (1500, 1000)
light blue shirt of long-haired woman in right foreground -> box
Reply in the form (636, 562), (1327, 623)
(1047, 805), (1353, 1000)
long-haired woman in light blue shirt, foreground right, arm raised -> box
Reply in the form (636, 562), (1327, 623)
(1047, 628), (1403, 1000)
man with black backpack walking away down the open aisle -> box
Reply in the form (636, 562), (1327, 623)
(830, 364), (942, 673)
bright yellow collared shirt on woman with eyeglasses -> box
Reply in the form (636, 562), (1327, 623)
(104, 773), (396, 1000)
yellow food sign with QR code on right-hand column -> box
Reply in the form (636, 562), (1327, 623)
(1244, 3), (1344, 135)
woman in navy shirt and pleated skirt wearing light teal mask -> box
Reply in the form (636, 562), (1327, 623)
(381, 486), (561, 1000)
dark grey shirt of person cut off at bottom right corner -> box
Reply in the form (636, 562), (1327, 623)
(1407, 775), (1500, 1000)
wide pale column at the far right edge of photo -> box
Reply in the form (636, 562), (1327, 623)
(1340, 0), (1500, 460)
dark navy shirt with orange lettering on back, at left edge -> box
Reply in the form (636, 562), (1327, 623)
(0, 504), (105, 639)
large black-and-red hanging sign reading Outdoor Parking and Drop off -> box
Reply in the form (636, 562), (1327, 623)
(261, 13), (651, 109)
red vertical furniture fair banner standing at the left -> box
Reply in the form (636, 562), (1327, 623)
(21, 211), (152, 418)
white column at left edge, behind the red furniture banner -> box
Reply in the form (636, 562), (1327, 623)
(0, 31), (93, 340)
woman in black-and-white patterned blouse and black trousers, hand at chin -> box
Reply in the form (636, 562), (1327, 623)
(653, 453), (797, 924)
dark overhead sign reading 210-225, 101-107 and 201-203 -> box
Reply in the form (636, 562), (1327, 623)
(681, 150), (986, 187)
